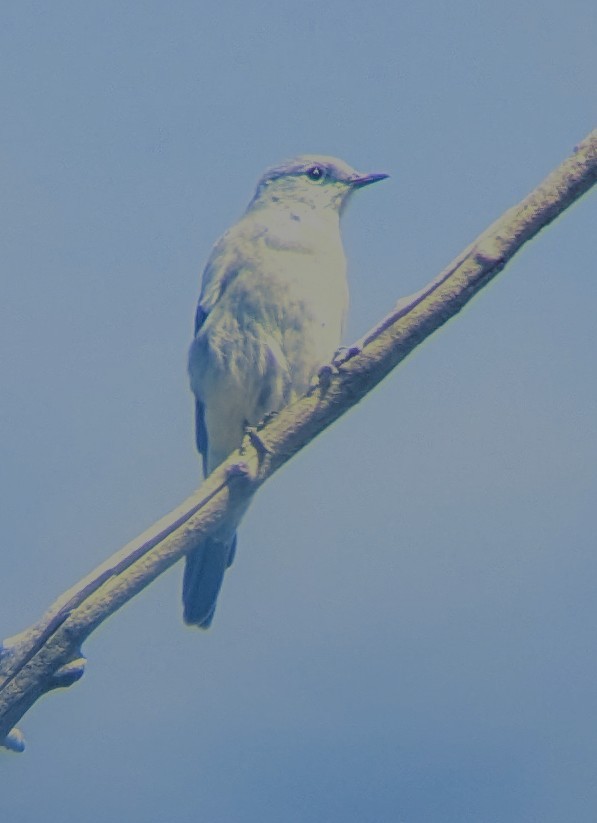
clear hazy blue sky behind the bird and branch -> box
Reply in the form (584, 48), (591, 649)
(0, 0), (597, 823)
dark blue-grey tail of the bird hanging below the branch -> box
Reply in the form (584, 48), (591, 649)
(182, 534), (236, 629)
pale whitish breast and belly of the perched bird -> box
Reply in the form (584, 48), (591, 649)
(189, 212), (348, 450)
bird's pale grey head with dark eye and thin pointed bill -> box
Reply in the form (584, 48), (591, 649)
(249, 154), (389, 213)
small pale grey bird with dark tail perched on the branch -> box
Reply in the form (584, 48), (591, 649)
(182, 154), (389, 629)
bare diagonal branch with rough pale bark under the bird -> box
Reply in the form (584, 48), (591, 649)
(0, 130), (597, 751)
